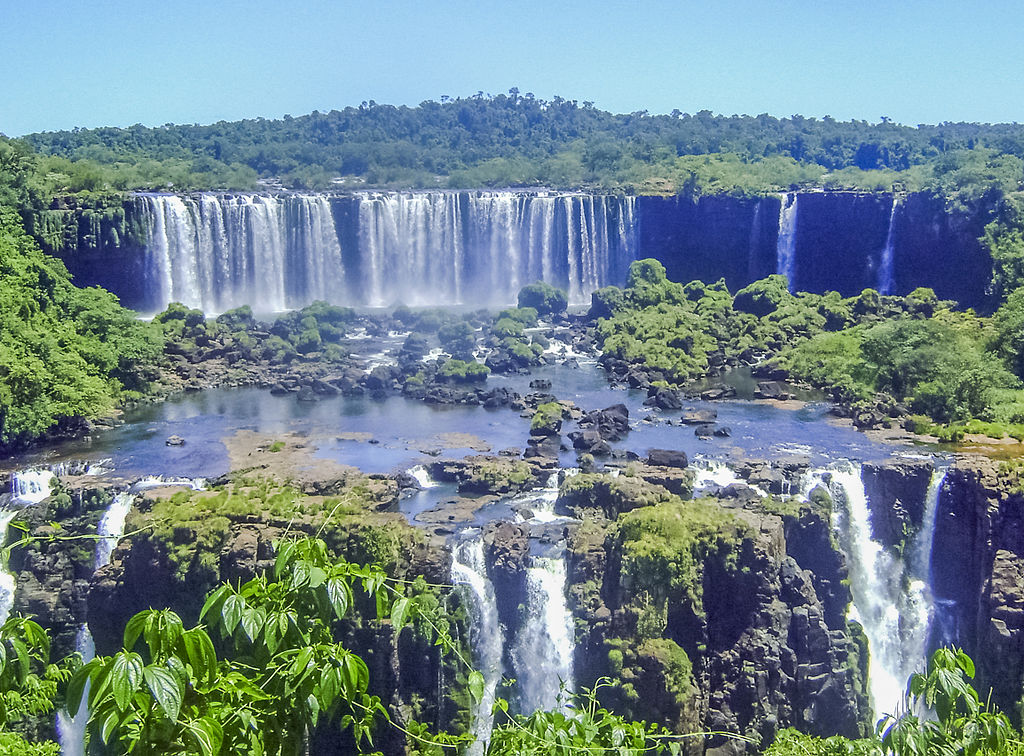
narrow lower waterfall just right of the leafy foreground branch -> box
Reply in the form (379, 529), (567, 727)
(452, 531), (504, 756)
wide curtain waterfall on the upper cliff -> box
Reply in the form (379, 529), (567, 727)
(133, 191), (636, 312)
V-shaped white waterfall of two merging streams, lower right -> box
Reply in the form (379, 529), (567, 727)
(823, 462), (945, 717)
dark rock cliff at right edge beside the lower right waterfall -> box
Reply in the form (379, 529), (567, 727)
(932, 458), (1024, 721)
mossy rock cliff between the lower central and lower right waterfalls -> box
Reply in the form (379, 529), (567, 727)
(568, 471), (868, 754)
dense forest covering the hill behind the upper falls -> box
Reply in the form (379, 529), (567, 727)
(7, 89), (1024, 201)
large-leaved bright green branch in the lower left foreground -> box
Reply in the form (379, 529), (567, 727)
(68, 539), (464, 756)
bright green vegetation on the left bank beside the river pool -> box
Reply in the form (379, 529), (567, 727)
(0, 207), (160, 449)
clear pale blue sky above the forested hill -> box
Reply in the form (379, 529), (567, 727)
(0, 0), (1024, 136)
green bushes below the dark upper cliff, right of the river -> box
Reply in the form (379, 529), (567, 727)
(590, 260), (1024, 440)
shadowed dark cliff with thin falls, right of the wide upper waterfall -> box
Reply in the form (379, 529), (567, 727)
(637, 192), (991, 307)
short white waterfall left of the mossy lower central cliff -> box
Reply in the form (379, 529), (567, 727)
(512, 556), (574, 714)
